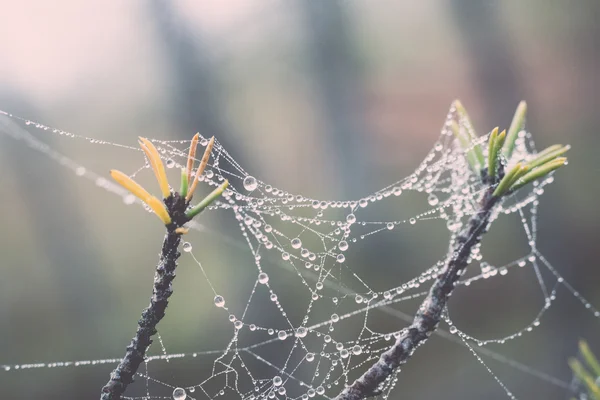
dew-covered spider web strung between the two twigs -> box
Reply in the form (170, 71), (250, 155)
(0, 109), (600, 400)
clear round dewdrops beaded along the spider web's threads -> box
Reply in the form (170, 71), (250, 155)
(4, 110), (600, 400)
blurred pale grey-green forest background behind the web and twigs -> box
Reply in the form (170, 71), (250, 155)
(0, 0), (600, 400)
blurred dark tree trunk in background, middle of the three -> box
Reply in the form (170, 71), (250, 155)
(297, 1), (369, 198)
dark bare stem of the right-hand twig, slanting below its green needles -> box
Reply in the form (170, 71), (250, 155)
(335, 186), (499, 400)
